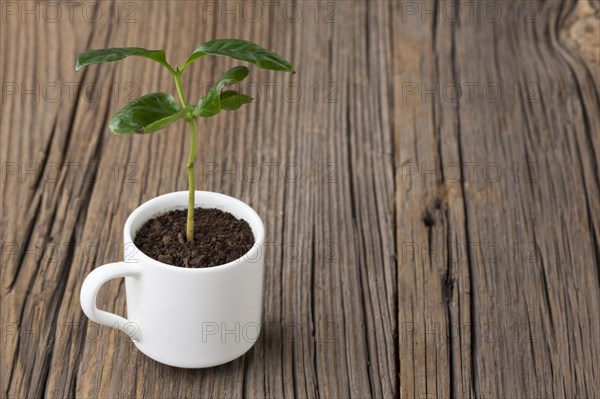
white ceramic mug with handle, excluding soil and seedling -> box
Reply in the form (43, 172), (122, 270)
(80, 191), (265, 368)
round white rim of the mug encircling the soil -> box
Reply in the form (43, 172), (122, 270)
(123, 190), (265, 273)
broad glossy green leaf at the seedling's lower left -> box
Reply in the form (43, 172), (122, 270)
(110, 93), (182, 133)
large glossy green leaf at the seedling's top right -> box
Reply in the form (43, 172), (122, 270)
(181, 39), (295, 73)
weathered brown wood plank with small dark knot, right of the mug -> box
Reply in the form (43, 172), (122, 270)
(394, 1), (600, 397)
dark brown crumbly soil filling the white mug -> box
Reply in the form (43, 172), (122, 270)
(134, 208), (254, 268)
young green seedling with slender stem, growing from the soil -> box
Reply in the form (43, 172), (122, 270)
(75, 39), (295, 241)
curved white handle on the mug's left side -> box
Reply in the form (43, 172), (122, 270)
(80, 262), (140, 342)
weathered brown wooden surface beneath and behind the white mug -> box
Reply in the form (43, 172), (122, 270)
(0, 0), (600, 398)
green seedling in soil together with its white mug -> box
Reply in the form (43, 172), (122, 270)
(75, 39), (294, 368)
